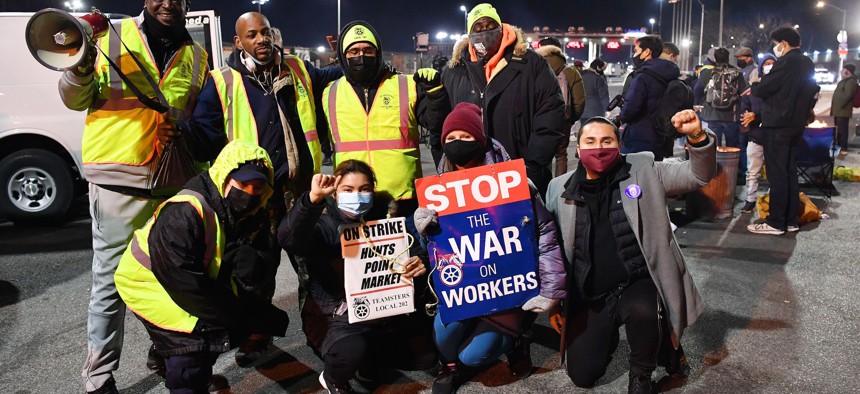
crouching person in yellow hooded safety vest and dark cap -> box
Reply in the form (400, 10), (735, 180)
(115, 141), (289, 393)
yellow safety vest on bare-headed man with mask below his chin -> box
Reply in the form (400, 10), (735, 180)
(212, 55), (322, 174)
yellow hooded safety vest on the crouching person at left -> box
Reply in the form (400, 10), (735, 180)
(114, 189), (225, 332)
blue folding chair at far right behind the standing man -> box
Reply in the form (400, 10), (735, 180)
(797, 127), (838, 200)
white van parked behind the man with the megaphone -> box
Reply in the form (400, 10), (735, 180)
(0, 11), (223, 223)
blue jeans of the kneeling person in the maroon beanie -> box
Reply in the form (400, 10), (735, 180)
(433, 314), (514, 367)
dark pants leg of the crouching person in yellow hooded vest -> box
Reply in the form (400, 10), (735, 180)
(164, 352), (218, 394)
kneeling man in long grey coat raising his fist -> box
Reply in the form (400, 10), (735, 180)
(547, 110), (717, 393)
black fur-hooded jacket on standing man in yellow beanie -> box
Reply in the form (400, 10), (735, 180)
(430, 25), (567, 193)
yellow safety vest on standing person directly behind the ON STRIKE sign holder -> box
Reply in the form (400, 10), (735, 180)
(323, 75), (421, 199)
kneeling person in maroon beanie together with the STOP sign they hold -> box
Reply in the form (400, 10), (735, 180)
(415, 103), (567, 393)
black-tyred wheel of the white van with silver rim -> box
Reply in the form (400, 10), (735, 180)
(0, 149), (74, 224)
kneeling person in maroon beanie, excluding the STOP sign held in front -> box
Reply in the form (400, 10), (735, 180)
(415, 103), (567, 394)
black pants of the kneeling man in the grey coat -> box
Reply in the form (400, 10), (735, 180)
(566, 277), (660, 387)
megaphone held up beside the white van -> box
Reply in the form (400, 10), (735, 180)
(24, 8), (110, 71)
